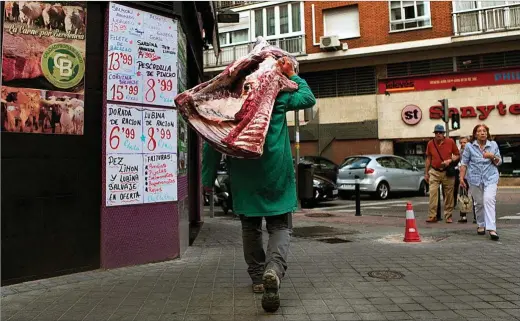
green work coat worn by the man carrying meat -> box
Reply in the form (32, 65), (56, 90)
(202, 75), (316, 216)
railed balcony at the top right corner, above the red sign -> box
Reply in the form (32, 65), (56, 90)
(453, 4), (520, 36)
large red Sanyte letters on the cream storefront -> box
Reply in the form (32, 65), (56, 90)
(430, 102), (520, 120)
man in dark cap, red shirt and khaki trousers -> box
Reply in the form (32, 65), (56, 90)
(424, 124), (460, 223)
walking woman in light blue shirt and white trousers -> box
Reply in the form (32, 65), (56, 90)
(460, 124), (502, 241)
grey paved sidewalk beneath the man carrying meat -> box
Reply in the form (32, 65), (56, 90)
(1, 217), (520, 321)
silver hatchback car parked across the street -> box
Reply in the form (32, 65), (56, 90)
(337, 154), (428, 199)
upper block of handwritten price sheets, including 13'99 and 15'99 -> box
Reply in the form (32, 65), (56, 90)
(107, 2), (177, 107)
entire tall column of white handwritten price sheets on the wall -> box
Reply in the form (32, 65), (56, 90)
(106, 3), (178, 206)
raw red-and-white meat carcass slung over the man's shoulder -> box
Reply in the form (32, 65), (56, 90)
(175, 37), (298, 158)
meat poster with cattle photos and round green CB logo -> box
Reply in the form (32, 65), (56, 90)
(0, 1), (87, 135)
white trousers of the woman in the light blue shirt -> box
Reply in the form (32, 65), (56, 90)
(469, 184), (497, 231)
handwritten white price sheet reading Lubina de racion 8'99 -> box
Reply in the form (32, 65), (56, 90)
(143, 109), (177, 153)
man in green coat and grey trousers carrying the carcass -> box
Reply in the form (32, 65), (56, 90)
(202, 57), (316, 312)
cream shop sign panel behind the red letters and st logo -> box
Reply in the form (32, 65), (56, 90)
(377, 84), (520, 139)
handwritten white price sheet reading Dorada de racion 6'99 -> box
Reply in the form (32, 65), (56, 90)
(106, 104), (143, 154)
